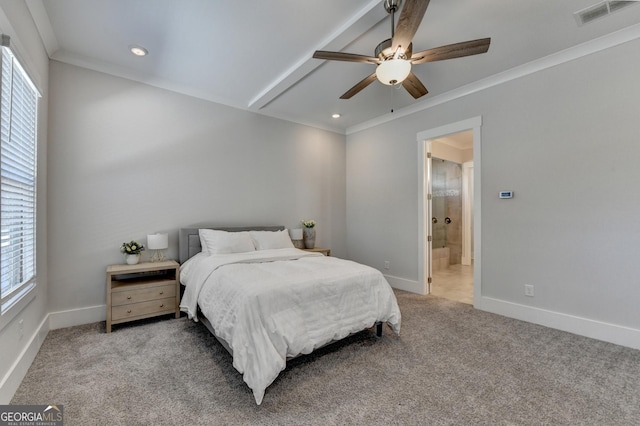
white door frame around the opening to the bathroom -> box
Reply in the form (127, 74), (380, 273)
(416, 116), (482, 308)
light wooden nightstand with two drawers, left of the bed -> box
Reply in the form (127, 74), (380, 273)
(107, 260), (180, 333)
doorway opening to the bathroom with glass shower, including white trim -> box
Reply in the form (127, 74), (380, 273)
(417, 117), (482, 307)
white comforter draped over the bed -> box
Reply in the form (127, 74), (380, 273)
(180, 249), (400, 404)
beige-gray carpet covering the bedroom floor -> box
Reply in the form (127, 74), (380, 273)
(12, 291), (640, 426)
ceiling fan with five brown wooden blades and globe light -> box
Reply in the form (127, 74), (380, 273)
(313, 0), (491, 99)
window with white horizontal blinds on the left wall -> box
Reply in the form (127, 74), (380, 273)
(0, 35), (39, 314)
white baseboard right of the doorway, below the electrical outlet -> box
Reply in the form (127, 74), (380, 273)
(474, 297), (640, 349)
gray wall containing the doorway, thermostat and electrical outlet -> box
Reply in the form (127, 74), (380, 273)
(347, 35), (640, 347)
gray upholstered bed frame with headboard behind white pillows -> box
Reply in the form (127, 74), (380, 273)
(178, 225), (382, 359)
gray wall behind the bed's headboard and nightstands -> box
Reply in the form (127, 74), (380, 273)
(49, 61), (346, 316)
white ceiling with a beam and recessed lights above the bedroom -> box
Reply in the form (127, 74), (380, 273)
(27, 0), (640, 133)
